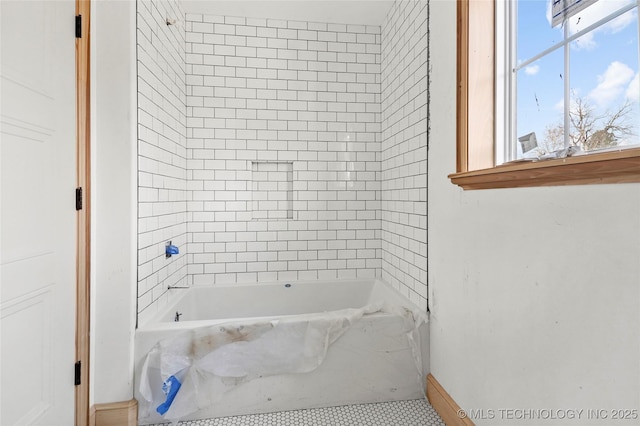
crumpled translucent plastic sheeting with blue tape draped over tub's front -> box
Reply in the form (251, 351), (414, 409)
(140, 303), (426, 422)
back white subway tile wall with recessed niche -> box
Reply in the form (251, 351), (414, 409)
(186, 15), (381, 284)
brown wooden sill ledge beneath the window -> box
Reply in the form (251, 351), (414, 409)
(449, 148), (640, 189)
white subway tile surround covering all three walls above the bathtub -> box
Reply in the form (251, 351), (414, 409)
(138, 1), (427, 324)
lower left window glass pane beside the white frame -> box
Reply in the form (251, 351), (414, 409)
(514, 49), (564, 158)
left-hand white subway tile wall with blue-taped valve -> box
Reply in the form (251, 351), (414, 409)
(137, 0), (187, 320)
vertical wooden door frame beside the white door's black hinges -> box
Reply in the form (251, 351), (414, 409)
(75, 0), (91, 426)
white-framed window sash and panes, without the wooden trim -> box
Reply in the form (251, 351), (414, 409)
(496, 0), (640, 164)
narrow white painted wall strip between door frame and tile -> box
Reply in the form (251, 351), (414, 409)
(91, 1), (137, 403)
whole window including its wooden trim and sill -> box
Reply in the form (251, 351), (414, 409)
(450, 0), (640, 189)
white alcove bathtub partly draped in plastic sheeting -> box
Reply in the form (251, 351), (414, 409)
(135, 280), (429, 424)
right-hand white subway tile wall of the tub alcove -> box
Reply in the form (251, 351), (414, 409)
(381, 0), (429, 309)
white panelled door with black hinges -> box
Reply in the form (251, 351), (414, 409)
(0, 0), (76, 426)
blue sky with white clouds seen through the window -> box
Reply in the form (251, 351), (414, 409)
(517, 0), (640, 156)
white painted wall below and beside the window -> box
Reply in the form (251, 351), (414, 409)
(428, 1), (640, 425)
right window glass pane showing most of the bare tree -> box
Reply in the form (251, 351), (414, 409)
(570, 6), (640, 151)
